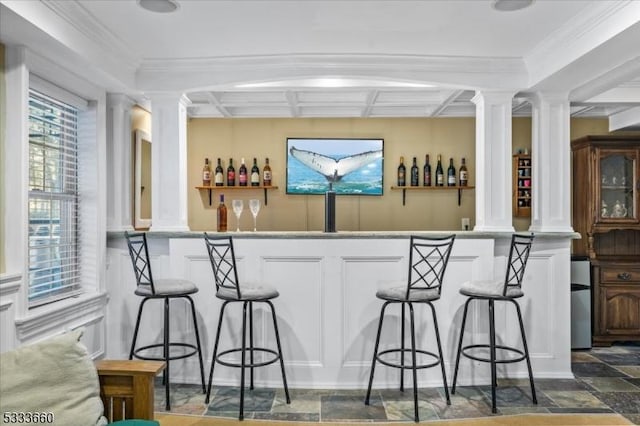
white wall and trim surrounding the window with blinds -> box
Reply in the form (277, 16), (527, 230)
(0, 46), (107, 358)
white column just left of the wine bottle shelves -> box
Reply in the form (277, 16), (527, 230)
(149, 93), (189, 231)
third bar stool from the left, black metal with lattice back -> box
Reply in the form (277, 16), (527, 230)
(364, 235), (455, 423)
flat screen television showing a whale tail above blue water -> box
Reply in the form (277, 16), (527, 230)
(287, 138), (384, 195)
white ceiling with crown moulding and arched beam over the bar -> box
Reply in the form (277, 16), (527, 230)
(0, 0), (640, 123)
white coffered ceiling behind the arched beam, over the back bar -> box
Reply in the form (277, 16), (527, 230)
(188, 88), (637, 118)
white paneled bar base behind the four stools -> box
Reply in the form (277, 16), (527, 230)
(107, 232), (575, 389)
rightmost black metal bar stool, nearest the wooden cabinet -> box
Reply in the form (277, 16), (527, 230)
(451, 234), (538, 413)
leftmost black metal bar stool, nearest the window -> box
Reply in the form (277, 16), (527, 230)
(124, 231), (205, 411)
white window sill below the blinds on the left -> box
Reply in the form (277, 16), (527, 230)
(16, 292), (107, 341)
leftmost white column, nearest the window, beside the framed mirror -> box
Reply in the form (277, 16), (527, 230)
(107, 93), (134, 231)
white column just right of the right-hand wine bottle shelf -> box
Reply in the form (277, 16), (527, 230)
(471, 91), (514, 232)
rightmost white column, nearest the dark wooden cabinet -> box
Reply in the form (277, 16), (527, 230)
(529, 93), (573, 232)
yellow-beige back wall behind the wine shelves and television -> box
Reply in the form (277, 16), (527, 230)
(187, 118), (475, 231)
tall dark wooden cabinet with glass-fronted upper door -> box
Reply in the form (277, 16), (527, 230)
(571, 135), (640, 345)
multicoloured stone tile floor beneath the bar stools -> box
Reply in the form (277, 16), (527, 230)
(155, 343), (640, 425)
